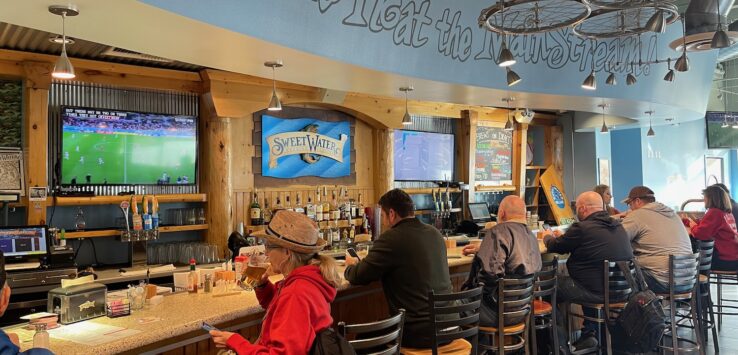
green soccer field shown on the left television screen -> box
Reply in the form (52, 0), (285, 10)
(61, 132), (197, 184)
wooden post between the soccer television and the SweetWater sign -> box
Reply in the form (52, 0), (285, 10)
(200, 93), (233, 258)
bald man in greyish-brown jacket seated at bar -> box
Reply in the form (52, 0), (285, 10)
(462, 196), (542, 327)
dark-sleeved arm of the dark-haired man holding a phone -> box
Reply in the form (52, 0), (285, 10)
(343, 236), (395, 285)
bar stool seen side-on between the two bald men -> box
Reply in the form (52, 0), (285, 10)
(530, 255), (559, 355)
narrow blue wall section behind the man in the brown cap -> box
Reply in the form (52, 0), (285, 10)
(610, 128), (643, 211)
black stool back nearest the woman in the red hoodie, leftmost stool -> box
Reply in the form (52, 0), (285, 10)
(338, 309), (405, 355)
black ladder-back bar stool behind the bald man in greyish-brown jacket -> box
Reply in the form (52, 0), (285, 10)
(479, 276), (535, 354)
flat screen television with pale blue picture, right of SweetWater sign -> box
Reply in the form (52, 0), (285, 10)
(394, 130), (454, 181)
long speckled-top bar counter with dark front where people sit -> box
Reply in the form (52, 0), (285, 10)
(14, 247), (472, 354)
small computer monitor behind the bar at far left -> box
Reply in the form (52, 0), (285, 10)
(0, 226), (47, 260)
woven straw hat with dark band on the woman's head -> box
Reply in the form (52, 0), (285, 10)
(252, 210), (326, 254)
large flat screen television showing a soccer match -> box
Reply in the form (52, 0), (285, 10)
(59, 107), (197, 185)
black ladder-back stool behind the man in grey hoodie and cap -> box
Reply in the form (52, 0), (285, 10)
(657, 253), (705, 354)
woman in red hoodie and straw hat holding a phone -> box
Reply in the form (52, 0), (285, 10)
(210, 210), (341, 354)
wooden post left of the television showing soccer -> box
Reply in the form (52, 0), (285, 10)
(23, 62), (51, 225)
